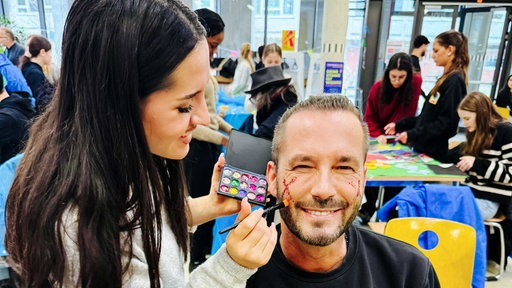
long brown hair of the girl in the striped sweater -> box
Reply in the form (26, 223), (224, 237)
(458, 92), (503, 156)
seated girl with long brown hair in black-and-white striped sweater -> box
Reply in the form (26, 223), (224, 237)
(453, 92), (512, 272)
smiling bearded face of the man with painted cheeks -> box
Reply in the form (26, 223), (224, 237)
(267, 111), (366, 246)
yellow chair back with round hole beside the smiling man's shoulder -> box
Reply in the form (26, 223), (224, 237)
(384, 217), (476, 288)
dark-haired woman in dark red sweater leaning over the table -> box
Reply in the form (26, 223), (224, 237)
(356, 52), (422, 224)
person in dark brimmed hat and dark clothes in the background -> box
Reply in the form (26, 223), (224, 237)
(245, 66), (298, 140)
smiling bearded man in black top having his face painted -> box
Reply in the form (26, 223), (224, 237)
(247, 96), (439, 288)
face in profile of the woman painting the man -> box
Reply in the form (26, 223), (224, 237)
(141, 40), (210, 159)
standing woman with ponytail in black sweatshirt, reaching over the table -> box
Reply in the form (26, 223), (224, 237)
(384, 30), (469, 162)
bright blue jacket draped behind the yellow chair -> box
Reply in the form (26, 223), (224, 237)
(377, 184), (487, 288)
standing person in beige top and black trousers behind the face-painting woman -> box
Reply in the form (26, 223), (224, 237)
(184, 8), (233, 271)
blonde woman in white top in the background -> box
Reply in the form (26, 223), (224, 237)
(228, 42), (254, 95)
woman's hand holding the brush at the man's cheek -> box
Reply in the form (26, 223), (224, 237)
(226, 198), (277, 269)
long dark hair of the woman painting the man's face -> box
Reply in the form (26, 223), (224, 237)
(6, 0), (205, 287)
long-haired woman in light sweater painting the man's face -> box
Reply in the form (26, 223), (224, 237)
(6, 0), (277, 287)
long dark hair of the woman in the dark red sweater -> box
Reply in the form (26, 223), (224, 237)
(380, 52), (412, 107)
